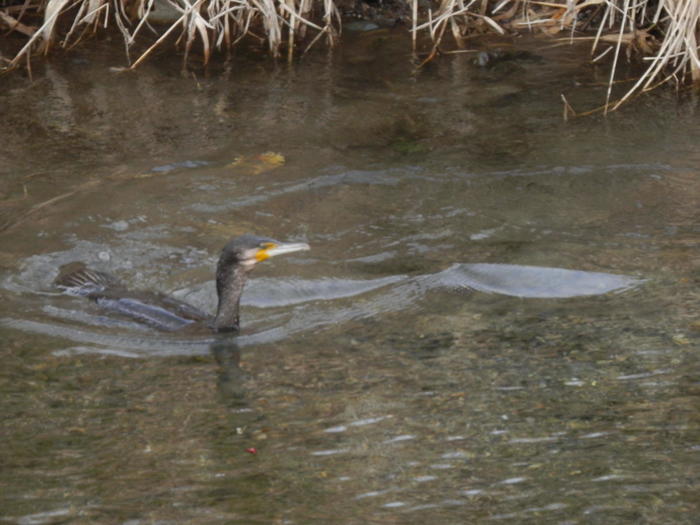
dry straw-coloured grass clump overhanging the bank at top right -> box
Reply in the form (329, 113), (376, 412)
(409, 0), (700, 113)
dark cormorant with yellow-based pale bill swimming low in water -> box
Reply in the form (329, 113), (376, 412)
(55, 234), (309, 332)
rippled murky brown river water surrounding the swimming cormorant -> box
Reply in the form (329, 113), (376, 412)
(0, 30), (700, 524)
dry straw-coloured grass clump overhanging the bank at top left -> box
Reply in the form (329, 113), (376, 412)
(0, 0), (340, 68)
